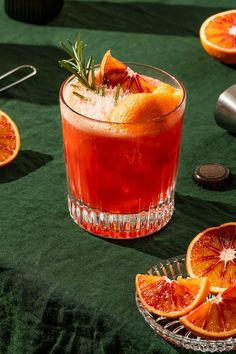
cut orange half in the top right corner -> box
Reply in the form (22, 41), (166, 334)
(200, 10), (236, 64)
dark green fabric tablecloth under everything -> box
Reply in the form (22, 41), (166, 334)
(0, 0), (236, 354)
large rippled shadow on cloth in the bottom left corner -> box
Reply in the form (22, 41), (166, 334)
(0, 271), (125, 354)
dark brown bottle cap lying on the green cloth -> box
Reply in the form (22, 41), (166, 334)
(193, 163), (231, 190)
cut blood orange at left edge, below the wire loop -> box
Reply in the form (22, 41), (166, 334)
(0, 111), (20, 167)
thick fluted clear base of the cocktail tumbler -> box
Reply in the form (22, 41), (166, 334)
(68, 191), (174, 239)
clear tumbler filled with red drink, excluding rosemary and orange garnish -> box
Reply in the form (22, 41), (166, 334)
(60, 63), (186, 239)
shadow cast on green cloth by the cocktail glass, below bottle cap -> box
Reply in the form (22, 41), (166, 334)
(106, 193), (236, 259)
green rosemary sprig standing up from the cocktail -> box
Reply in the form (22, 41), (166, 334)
(59, 36), (96, 91)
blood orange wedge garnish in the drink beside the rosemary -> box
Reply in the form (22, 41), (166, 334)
(96, 50), (158, 93)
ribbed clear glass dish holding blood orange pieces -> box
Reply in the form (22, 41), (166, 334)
(136, 255), (236, 353)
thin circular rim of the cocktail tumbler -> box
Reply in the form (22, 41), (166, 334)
(59, 61), (186, 125)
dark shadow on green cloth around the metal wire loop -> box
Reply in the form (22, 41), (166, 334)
(0, 43), (68, 105)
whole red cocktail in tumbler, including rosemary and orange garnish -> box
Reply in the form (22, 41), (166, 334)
(60, 39), (186, 239)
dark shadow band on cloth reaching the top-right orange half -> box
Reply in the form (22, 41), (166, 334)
(49, 1), (228, 37)
